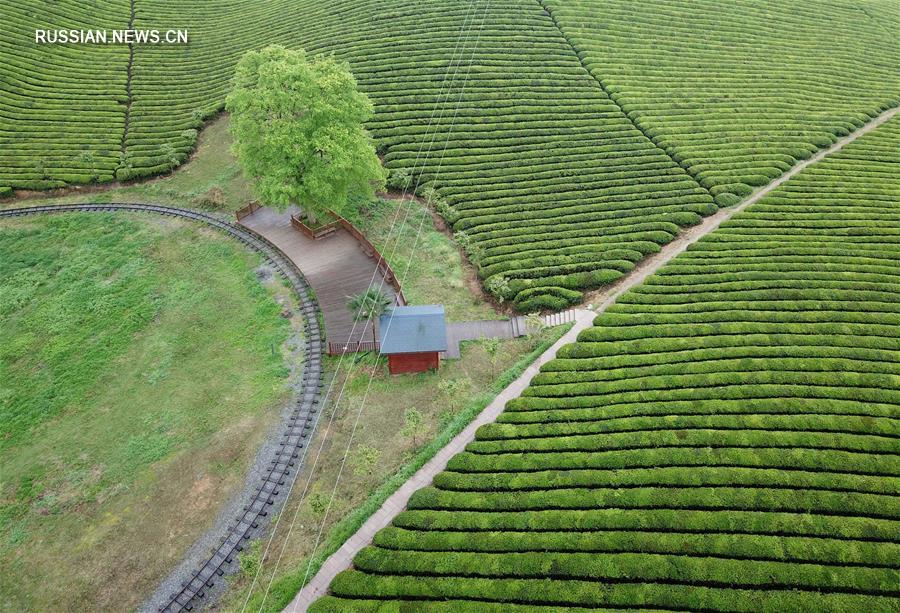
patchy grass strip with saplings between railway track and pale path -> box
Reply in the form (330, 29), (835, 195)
(219, 327), (567, 611)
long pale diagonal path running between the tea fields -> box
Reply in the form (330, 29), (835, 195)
(285, 103), (900, 613)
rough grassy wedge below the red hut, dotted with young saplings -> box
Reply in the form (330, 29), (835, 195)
(222, 326), (568, 611)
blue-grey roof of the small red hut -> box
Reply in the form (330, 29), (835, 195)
(378, 304), (447, 354)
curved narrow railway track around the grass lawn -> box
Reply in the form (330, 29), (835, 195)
(0, 203), (324, 613)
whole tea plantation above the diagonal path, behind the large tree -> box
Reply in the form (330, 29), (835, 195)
(0, 0), (898, 310)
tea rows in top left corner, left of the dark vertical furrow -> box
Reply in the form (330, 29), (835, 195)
(0, 0), (128, 189)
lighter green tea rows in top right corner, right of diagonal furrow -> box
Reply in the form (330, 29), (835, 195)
(543, 0), (900, 206)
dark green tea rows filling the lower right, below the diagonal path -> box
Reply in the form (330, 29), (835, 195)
(311, 118), (900, 612)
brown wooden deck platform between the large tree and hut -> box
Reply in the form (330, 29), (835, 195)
(240, 208), (396, 344)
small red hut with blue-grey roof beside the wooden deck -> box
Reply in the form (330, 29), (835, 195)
(378, 304), (447, 375)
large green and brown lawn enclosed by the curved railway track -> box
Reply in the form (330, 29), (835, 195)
(0, 214), (293, 611)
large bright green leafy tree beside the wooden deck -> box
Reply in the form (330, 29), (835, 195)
(225, 45), (385, 221)
